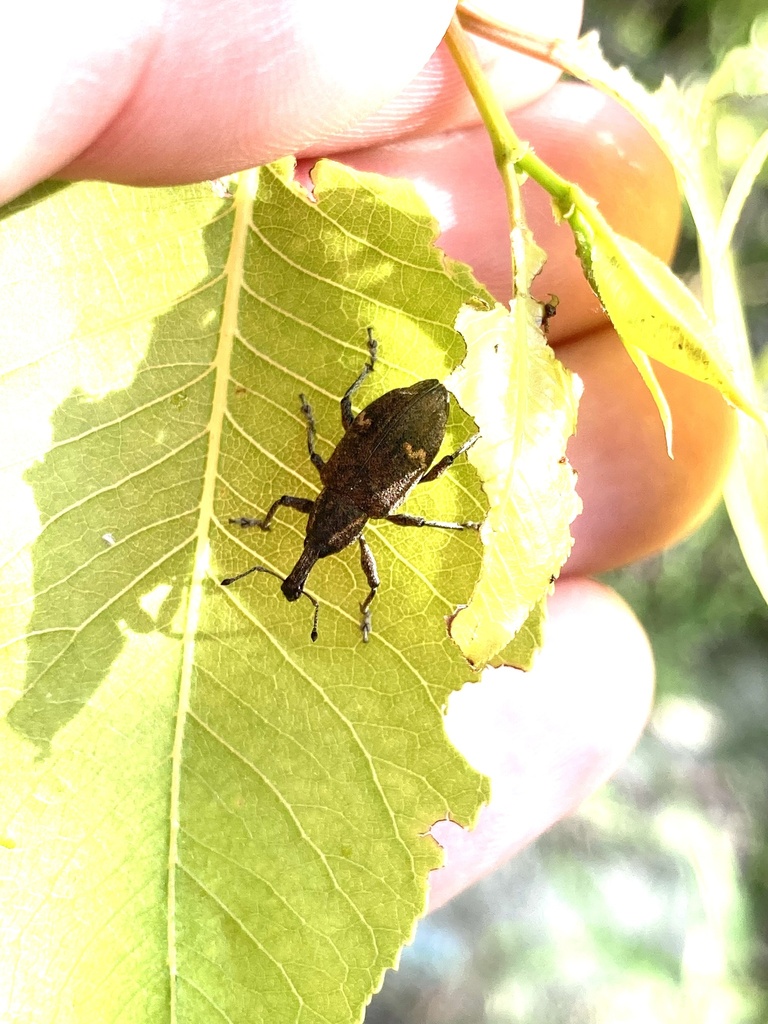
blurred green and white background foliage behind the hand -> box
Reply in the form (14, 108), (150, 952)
(366, 0), (768, 1024)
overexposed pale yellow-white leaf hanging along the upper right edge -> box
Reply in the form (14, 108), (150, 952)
(540, 33), (768, 601)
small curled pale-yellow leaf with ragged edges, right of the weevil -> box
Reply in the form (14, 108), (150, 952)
(447, 296), (582, 667)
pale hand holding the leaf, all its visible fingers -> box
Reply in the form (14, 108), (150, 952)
(0, 0), (734, 905)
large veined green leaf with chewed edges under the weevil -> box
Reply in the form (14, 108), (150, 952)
(0, 164), (487, 1024)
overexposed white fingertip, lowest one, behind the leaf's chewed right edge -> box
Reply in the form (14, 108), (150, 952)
(430, 579), (653, 909)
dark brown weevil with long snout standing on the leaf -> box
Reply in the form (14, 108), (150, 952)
(221, 328), (479, 642)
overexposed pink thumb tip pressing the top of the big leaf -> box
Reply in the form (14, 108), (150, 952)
(58, 0), (462, 184)
